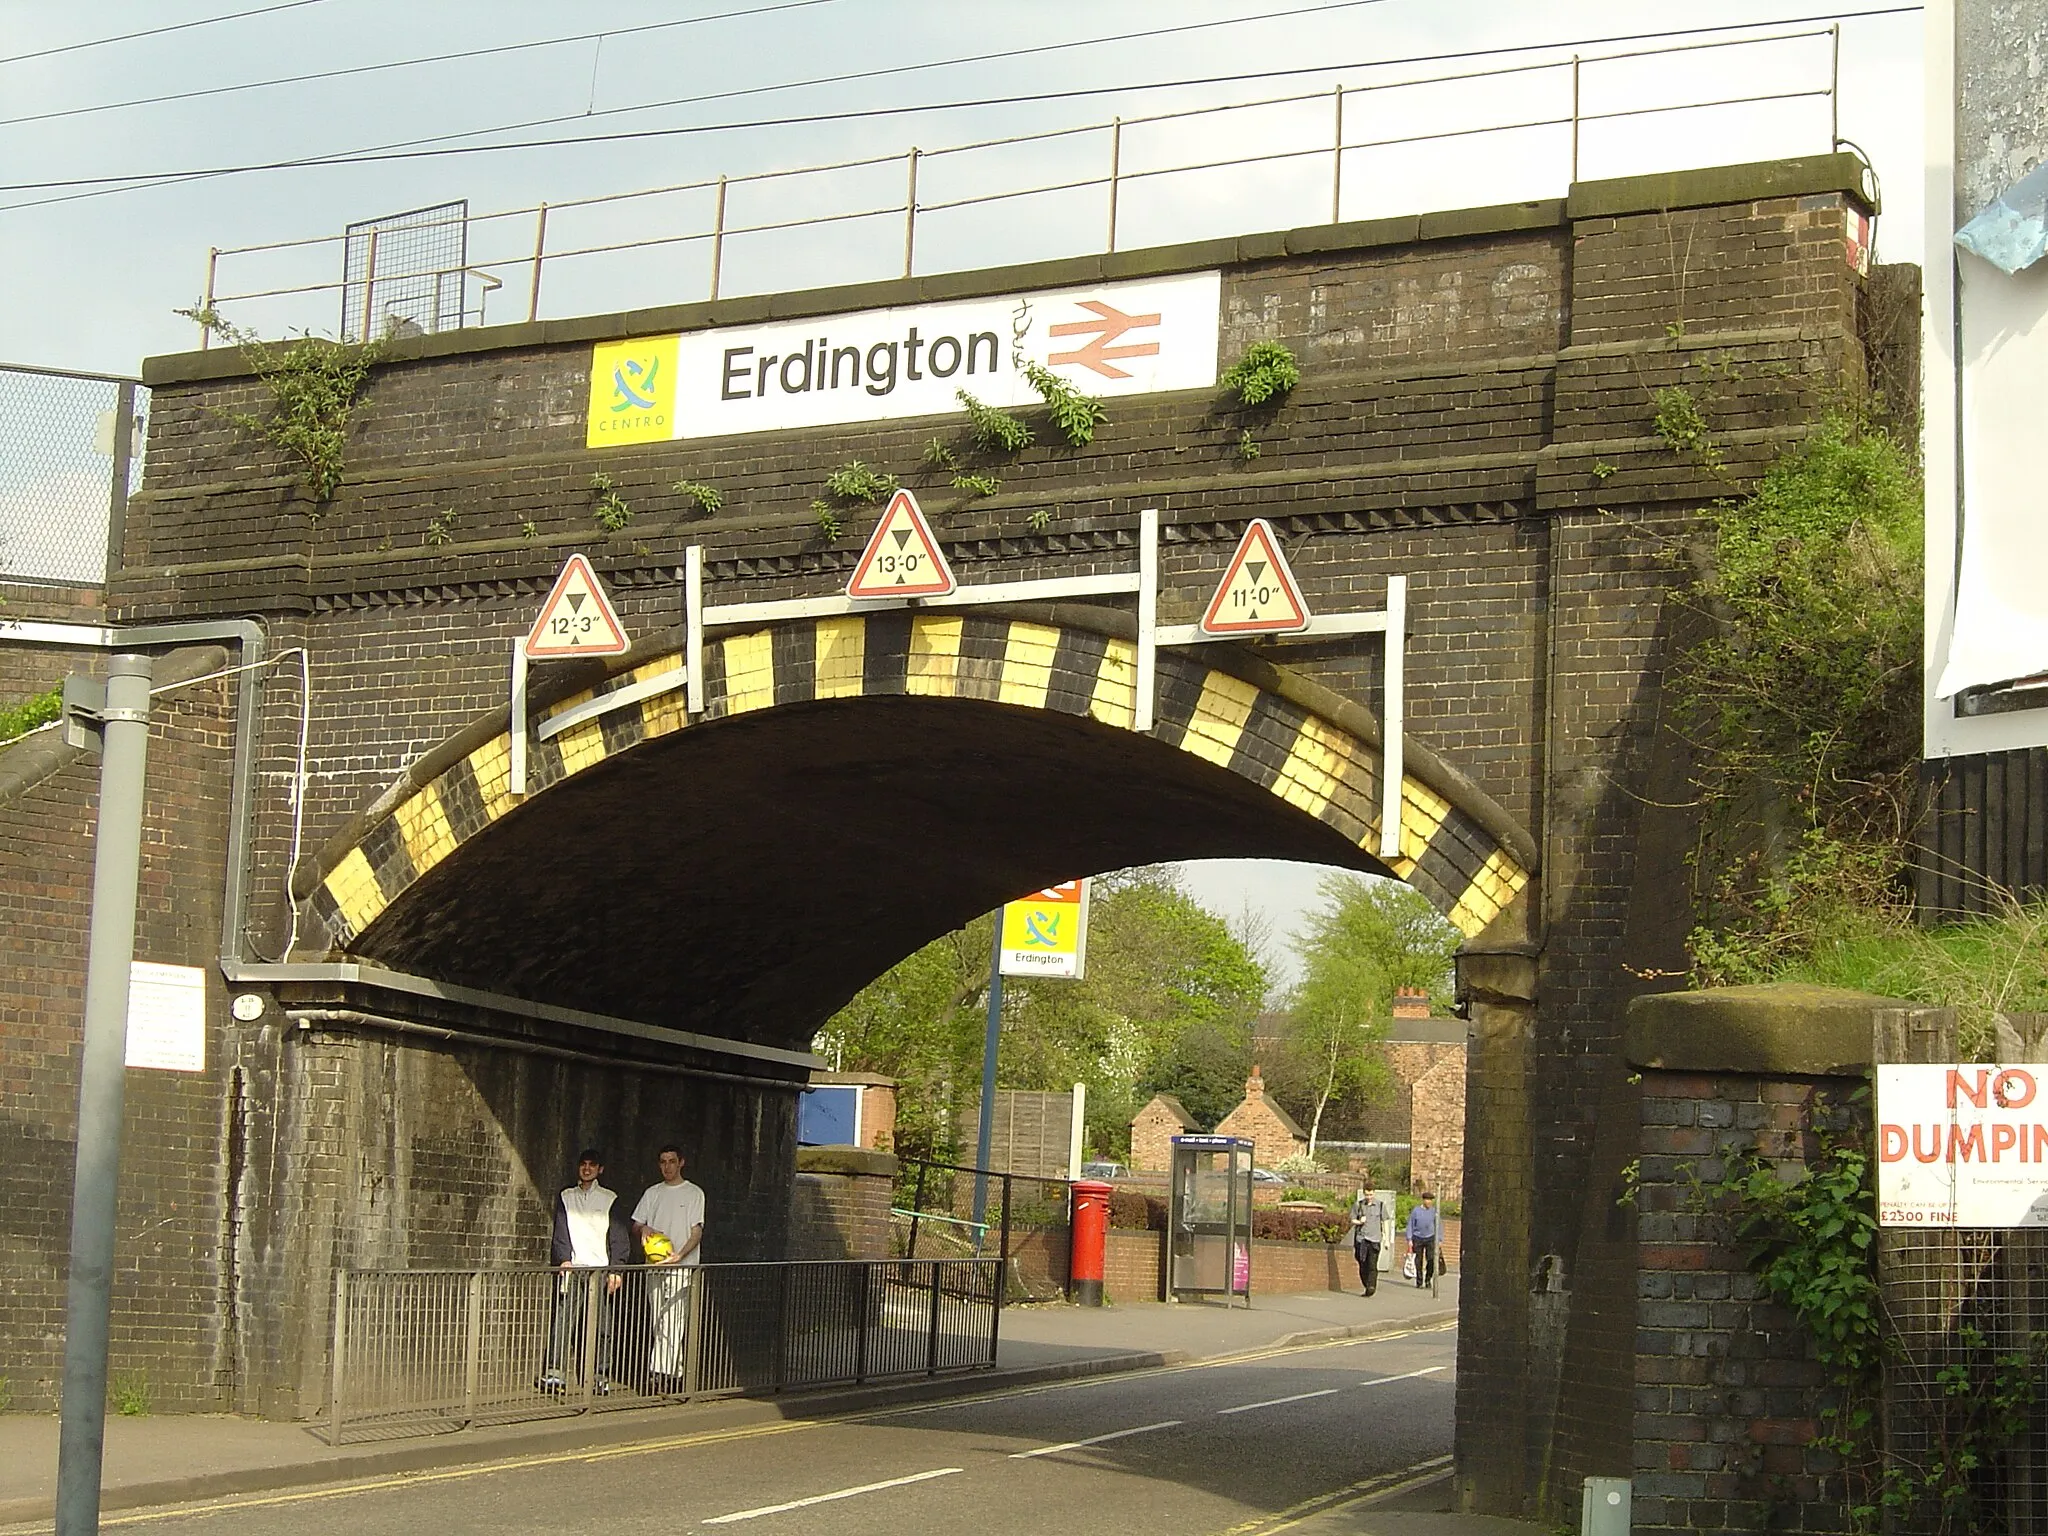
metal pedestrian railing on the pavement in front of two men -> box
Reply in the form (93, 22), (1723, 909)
(328, 1260), (1004, 1444)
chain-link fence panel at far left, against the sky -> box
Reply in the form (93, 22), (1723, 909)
(0, 362), (150, 586)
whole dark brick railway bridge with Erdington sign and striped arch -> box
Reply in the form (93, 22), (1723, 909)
(0, 156), (1896, 1509)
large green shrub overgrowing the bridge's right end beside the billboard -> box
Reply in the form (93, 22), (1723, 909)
(1671, 412), (1921, 983)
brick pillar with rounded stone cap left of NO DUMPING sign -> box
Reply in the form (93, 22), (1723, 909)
(1628, 987), (1896, 1532)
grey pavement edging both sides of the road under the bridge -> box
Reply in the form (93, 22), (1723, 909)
(0, 1276), (1548, 1536)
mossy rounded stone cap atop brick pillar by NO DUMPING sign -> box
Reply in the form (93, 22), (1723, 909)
(1624, 981), (1917, 1077)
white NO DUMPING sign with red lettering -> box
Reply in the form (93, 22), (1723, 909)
(1878, 1063), (2048, 1227)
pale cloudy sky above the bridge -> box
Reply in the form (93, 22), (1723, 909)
(0, 0), (1919, 373)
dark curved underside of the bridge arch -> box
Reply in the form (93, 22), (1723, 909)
(352, 696), (1386, 1049)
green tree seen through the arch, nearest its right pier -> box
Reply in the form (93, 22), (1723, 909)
(1276, 874), (1460, 1157)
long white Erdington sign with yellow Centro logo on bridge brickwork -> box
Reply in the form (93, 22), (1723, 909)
(586, 272), (1223, 449)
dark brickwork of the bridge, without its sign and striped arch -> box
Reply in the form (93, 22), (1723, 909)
(0, 158), (1892, 1511)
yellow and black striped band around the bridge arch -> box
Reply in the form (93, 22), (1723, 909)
(307, 610), (1530, 948)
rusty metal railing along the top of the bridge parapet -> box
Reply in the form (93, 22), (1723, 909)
(199, 25), (1843, 346)
